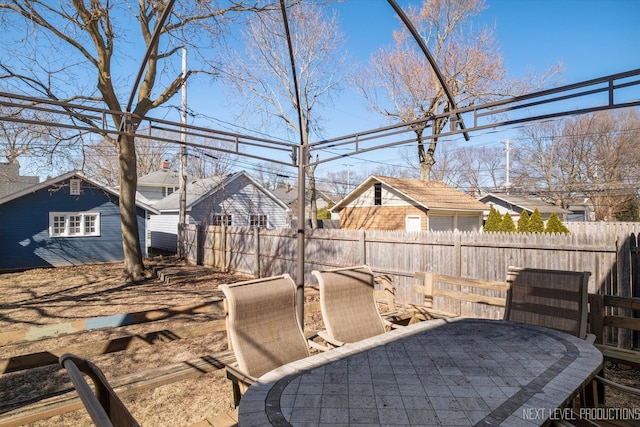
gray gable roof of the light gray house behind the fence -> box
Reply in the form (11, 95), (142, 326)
(153, 171), (289, 212)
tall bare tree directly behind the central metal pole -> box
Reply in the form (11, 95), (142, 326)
(224, 3), (345, 228)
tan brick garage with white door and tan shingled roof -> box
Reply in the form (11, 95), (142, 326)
(331, 175), (487, 231)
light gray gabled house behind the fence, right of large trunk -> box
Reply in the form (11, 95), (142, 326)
(147, 171), (290, 252)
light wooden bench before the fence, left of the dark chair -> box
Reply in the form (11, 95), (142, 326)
(413, 271), (508, 317)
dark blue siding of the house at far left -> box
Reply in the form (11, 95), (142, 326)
(0, 181), (145, 270)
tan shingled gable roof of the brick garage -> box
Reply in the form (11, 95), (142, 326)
(331, 175), (487, 211)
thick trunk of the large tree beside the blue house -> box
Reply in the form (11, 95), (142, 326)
(118, 135), (144, 280)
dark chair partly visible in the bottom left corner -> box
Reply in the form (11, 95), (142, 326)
(59, 353), (140, 427)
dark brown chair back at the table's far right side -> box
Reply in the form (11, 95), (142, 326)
(504, 267), (591, 339)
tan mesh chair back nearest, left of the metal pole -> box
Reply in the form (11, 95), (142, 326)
(220, 274), (309, 378)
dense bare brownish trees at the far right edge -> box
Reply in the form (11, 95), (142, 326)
(512, 109), (640, 220)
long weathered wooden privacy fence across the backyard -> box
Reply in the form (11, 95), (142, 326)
(184, 223), (640, 348)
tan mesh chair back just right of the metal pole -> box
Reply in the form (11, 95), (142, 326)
(311, 265), (385, 343)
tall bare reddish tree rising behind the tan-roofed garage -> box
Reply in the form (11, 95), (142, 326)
(355, 0), (556, 180)
